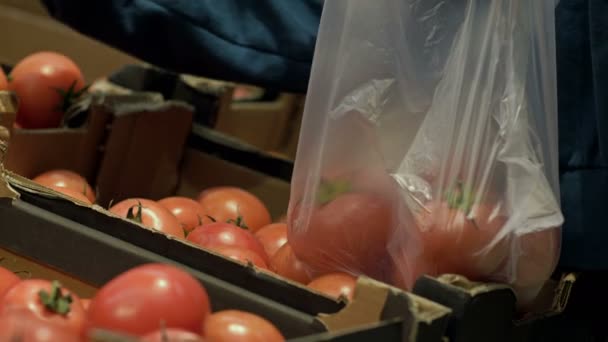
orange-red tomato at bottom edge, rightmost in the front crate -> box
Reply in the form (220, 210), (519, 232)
(203, 310), (285, 342)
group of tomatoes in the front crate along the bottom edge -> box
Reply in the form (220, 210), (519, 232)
(0, 264), (285, 342)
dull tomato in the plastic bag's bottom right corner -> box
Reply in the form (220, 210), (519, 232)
(512, 229), (561, 308)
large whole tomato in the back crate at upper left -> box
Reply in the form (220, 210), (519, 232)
(9, 51), (85, 128)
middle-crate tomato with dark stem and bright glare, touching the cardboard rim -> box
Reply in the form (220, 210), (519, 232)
(110, 198), (185, 238)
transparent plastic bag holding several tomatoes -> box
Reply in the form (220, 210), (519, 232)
(288, 0), (563, 305)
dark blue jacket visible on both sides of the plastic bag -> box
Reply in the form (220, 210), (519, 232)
(43, 0), (608, 269)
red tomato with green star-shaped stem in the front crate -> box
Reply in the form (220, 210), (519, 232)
(0, 279), (86, 334)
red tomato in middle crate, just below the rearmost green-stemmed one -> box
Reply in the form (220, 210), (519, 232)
(188, 222), (268, 261)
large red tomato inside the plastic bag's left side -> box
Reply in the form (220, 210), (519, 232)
(288, 192), (393, 276)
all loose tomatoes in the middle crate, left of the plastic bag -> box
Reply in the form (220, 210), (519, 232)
(33, 170), (356, 300)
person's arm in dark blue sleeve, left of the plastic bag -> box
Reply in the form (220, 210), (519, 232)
(42, 0), (322, 92)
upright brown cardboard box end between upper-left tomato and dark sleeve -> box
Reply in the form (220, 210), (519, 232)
(96, 98), (193, 206)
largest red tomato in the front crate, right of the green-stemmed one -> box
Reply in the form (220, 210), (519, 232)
(88, 264), (211, 336)
